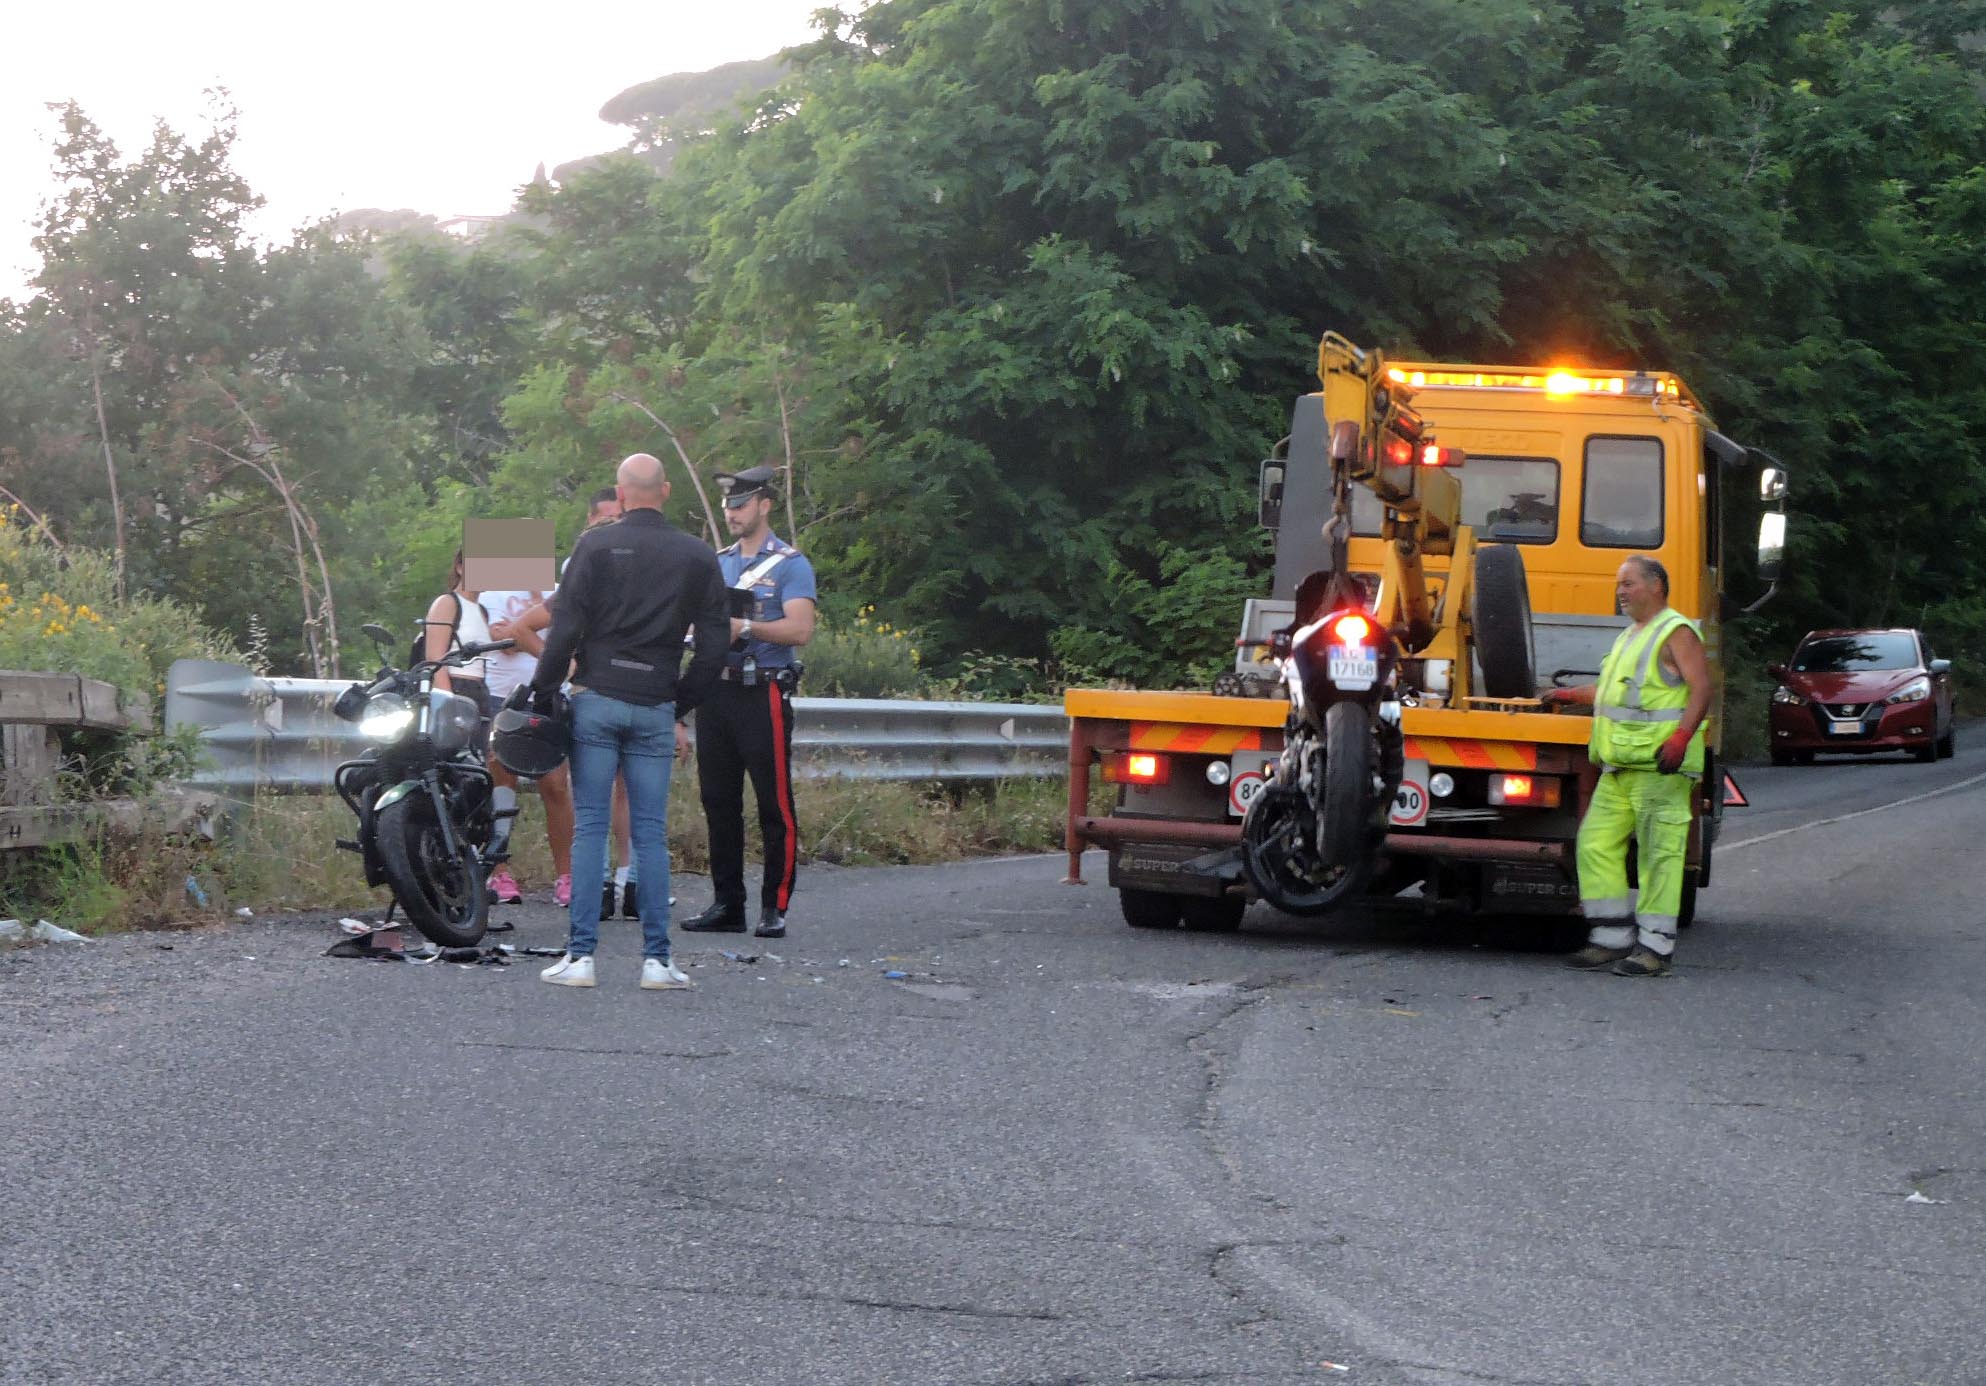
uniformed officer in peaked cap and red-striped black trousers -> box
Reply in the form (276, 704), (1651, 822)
(681, 467), (814, 939)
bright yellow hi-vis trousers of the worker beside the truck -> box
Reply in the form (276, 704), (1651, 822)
(1579, 770), (1696, 957)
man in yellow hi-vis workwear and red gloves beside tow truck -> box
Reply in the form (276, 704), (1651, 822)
(1545, 554), (1710, 977)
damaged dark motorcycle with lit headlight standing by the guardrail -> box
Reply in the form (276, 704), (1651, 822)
(332, 625), (514, 947)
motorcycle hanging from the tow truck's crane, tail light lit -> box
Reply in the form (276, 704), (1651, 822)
(1241, 580), (1406, 915)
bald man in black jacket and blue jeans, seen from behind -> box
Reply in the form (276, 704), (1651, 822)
(532, 453), (731, 991)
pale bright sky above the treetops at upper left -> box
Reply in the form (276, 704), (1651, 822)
(0, 0), (822, 296)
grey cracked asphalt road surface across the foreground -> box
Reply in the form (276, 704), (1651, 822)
(0, 745), (1986, 1386)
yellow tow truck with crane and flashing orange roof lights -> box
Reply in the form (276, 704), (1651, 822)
(1064, 334), (1785, 929)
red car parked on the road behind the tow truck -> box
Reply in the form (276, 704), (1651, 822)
(1766, 629), (1952, 764)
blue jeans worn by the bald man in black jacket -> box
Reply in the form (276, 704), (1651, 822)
(566, 691), (675, 959)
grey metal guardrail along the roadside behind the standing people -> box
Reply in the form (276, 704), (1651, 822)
(165, 659), (1068, 794)
